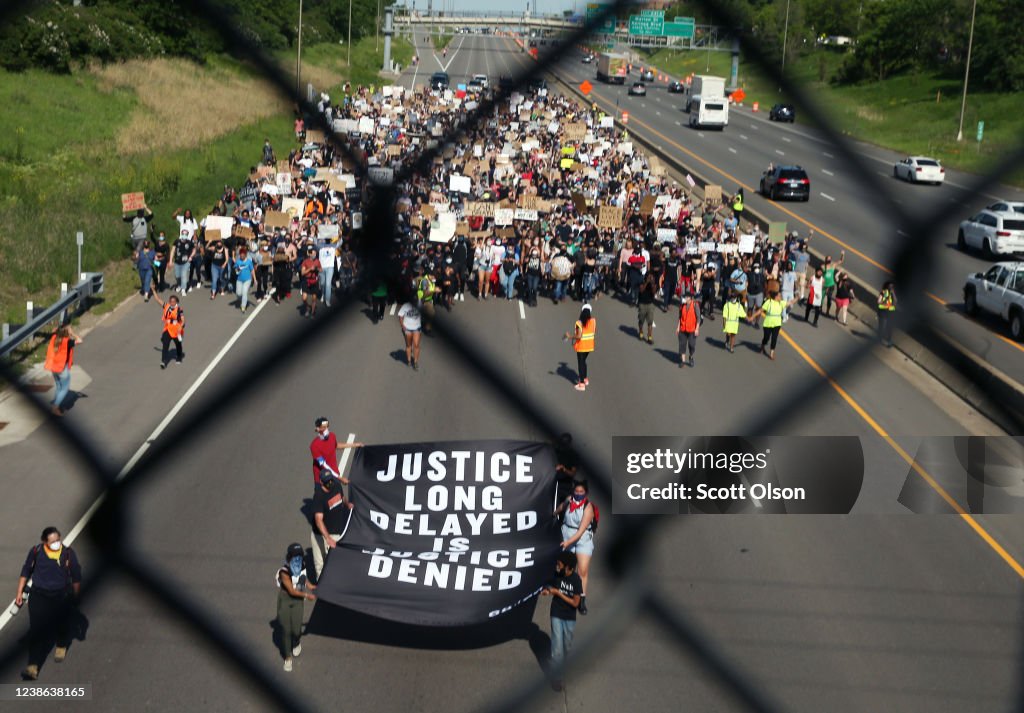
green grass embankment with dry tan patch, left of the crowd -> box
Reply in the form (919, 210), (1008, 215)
(0, 38), (412, 362)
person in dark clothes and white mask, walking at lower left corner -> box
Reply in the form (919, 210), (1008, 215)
(14, 527), (82, 681)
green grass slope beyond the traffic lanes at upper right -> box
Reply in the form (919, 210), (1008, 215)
(649, 49), (1024, 185)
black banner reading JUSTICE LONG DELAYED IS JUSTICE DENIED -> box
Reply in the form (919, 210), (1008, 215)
(316, 441), (559, 626)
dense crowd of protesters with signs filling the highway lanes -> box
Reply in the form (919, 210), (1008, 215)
(126, 74), (895, 376)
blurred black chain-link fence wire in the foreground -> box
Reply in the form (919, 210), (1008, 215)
(0, 0), (1024, 713)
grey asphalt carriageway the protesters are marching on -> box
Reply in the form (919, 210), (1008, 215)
(0, 36), (1024, 713)
